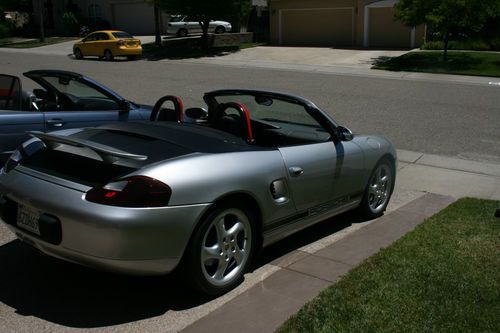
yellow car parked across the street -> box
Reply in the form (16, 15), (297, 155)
(73, 30), (142, 60)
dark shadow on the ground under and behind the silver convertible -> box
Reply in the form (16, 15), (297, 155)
(0, 213), (370, 328)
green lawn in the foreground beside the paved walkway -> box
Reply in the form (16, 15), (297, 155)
(278, 199), (500, 333)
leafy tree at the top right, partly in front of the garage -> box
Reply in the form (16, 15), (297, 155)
(394, 0), (500, 61)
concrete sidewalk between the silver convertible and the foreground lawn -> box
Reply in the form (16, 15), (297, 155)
(182, 150), (500, 333)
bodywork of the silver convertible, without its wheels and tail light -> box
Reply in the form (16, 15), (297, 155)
(0, 90), (396, 274)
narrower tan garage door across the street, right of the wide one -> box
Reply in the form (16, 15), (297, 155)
(369, 8), (411, 48)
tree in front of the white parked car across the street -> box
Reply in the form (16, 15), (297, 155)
(149, 0), (251, 48)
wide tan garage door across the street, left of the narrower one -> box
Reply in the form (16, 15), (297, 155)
(280, 8), (353, 46)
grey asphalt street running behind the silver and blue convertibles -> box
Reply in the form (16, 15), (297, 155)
(0, 52), (500, 162)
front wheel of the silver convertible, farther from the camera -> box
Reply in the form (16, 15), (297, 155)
(359, 158), (395, 219)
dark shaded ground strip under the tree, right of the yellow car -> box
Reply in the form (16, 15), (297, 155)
(142, 39), (265, 60)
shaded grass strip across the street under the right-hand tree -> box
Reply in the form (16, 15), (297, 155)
(372, 51), (500, 77)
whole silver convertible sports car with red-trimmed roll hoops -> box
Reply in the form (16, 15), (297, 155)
(0, 90), (396, 294)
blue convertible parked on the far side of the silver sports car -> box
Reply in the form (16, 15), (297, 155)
(0, 70), (151, 165)
